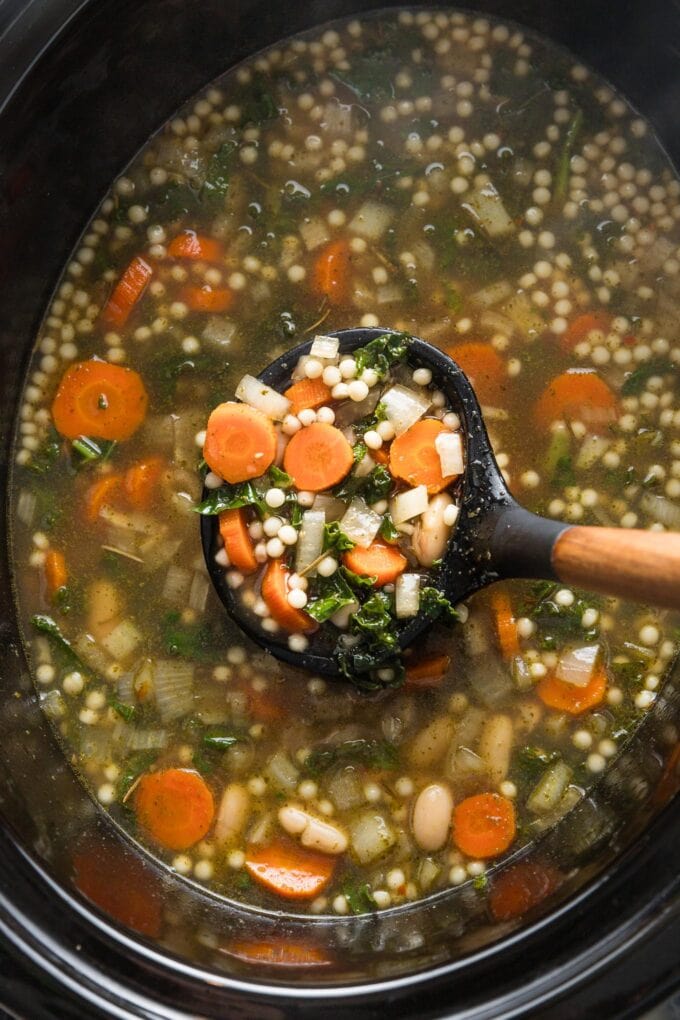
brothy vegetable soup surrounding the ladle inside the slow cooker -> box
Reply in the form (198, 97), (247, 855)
(12, 5), (680, 918)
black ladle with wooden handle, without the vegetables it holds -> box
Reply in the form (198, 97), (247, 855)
(201, 328), (680, 676)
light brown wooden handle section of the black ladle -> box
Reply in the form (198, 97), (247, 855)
(553, 527), (680, 609)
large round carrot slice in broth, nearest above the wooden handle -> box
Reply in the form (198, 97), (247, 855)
(533, 368), (617, 431)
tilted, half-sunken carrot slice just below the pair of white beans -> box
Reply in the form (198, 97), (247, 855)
(246, 843), (335, 900)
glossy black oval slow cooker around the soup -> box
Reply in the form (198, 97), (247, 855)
(0, 0), (680, 1020)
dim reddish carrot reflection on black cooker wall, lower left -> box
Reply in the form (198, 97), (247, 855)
(73, 839), (163, 938)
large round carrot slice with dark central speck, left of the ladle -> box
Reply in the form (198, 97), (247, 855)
(52, 359), (149, 441)
